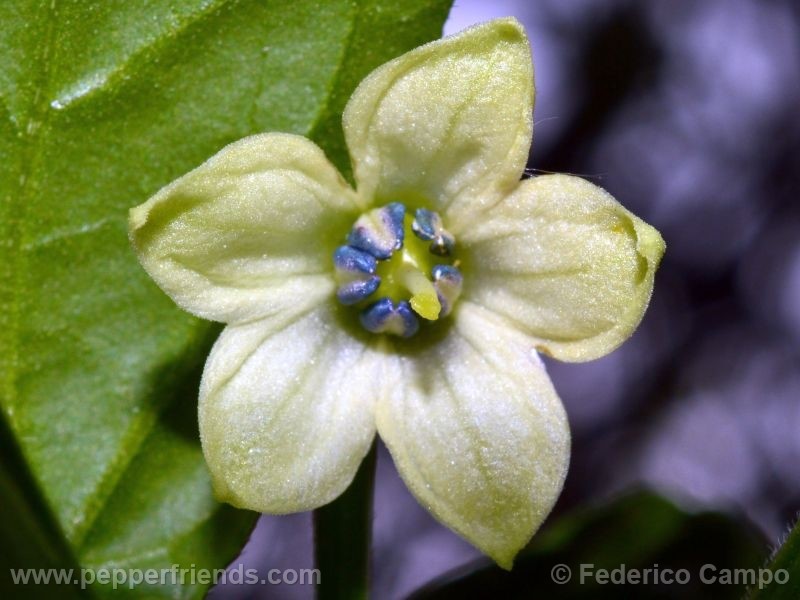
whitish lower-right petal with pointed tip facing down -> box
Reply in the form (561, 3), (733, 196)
(376, 302), (569, 568)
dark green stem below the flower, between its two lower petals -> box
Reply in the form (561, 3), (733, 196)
(314, 443), (376, 600)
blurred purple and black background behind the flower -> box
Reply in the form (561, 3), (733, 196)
(211, 0), (800, 599)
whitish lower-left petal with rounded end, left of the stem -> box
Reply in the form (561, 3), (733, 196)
(199, 303), (380, 513)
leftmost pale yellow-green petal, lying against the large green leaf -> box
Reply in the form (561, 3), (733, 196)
(130, 134), (359, 322)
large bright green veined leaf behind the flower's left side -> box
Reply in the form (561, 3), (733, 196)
(0, 0), (449, 597)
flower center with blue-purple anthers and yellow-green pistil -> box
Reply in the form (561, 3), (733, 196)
(333, 202), (462, 337)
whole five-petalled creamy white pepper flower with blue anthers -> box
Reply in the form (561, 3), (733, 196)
(130, 19), (664, 568)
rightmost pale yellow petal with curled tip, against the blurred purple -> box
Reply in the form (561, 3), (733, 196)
(459, 175), (665, 361)
